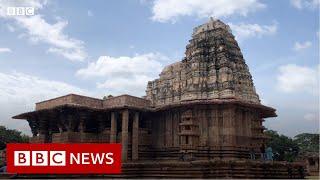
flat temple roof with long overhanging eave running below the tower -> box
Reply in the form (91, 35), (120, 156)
(12, 94), (277, 119)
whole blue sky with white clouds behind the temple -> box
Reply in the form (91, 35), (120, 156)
(0, 0), (320, 136)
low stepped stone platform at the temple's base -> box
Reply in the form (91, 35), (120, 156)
(12, 160), (305, 179)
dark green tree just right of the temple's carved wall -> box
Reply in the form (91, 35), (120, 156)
(265, 130), (299, 162)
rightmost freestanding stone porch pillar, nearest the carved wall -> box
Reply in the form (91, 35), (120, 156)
(132, 112), (139, 160)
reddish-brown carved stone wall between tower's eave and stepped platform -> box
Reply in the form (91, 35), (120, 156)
(152, 104), (265, 159)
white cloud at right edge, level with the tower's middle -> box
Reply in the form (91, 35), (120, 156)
(277, 64), (320, 95)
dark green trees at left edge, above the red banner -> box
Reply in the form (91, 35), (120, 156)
(0, 126), (29, 150)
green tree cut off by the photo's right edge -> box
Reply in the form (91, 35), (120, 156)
(294, 133), (319, 154)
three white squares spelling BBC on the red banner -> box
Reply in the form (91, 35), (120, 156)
(14, 151), (66, 166)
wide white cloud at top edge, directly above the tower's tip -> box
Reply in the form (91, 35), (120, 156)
(151, 0), (266, 23)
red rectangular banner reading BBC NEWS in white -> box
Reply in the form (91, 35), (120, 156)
(7, 143), (121, 174)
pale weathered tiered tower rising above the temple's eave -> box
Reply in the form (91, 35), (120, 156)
(146, 18), (260, 106)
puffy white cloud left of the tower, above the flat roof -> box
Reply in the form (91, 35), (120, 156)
(77, 53), (168, 96)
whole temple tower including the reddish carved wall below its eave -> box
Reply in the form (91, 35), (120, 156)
(146, 18), (276, 157)
